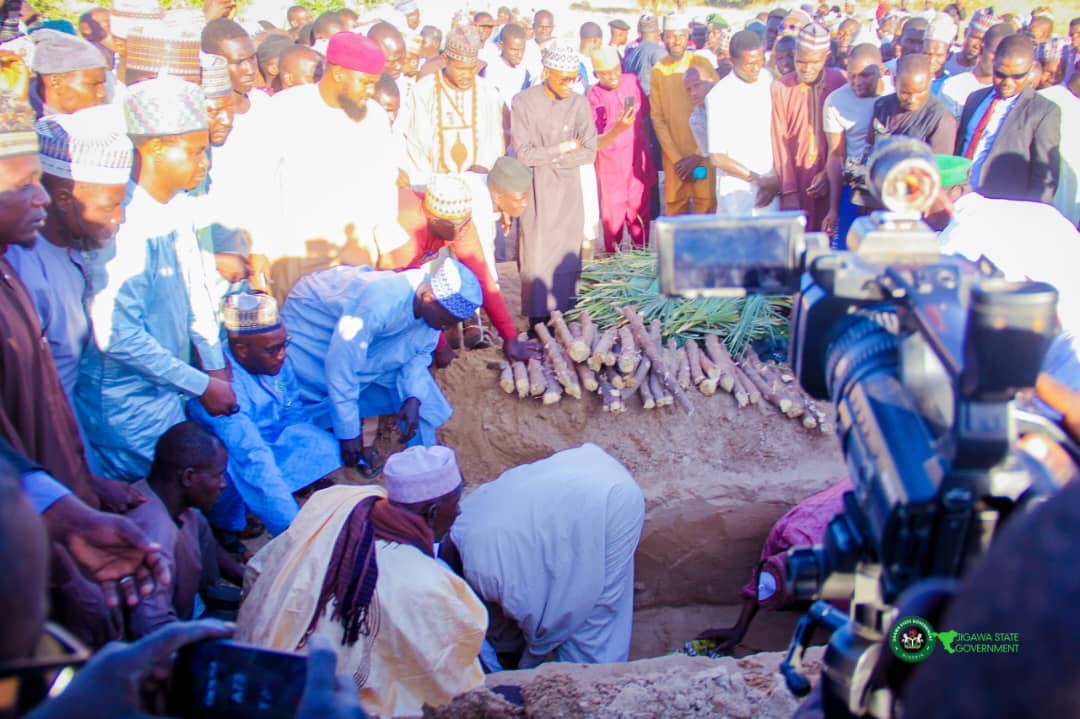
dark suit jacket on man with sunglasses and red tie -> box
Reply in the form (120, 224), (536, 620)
(956, 85), (1062, 204)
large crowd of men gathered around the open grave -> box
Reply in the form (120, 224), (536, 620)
(0, 0), (1080, 716)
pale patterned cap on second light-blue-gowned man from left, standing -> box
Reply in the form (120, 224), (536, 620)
(124, 74), (208, 136)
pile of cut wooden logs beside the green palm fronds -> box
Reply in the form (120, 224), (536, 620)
(499, 307), (836, 434)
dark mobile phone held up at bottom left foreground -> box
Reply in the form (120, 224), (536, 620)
(167, 639), (307, 719)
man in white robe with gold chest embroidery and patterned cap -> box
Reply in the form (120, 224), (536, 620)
(405, 26), (505, 185)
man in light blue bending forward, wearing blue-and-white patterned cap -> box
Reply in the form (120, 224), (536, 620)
(282, 257), (483, 465)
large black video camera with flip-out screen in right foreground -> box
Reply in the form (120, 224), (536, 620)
(653, 138), (1057, 718)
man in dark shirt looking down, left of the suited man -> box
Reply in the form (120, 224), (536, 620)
(866, 54), (957, 158)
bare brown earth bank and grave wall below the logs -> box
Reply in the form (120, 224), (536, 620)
(429, 263), (847, 682)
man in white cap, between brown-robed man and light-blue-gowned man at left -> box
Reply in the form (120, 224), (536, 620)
(8, 108), (133, 398)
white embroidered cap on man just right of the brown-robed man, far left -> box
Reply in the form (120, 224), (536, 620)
(35, 106), (135, 185)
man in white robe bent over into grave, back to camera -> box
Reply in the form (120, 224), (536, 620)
(440, 444), (645, 668)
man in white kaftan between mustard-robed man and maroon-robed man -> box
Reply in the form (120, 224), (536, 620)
(705, 30), (780, 215)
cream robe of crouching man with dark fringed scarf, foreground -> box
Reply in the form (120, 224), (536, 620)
(237, 486), (487, 717)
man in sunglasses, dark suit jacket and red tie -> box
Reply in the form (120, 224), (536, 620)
(956, 35), (1062, 203)
